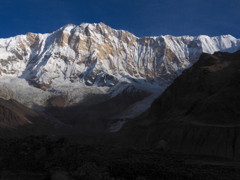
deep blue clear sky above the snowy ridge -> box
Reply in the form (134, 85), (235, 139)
(0, 0), (240, 38)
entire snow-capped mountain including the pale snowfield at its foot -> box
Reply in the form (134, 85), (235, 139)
(0, 23), (240, 118)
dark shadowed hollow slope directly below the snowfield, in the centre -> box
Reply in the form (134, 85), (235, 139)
(47, 86), (150, 135)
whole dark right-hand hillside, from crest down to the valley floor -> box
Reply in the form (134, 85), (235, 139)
(120, 51), (240, 158)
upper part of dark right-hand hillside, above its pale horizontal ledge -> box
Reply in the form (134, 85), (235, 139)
(150, 51), (240, 125)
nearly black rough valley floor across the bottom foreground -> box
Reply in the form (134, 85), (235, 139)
(0, 136), (240, 180)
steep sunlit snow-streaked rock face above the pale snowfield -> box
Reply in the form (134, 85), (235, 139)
(0, 23), (240, 89)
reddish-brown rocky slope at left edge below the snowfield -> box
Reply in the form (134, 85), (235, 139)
(0, 98), (55, 138)
